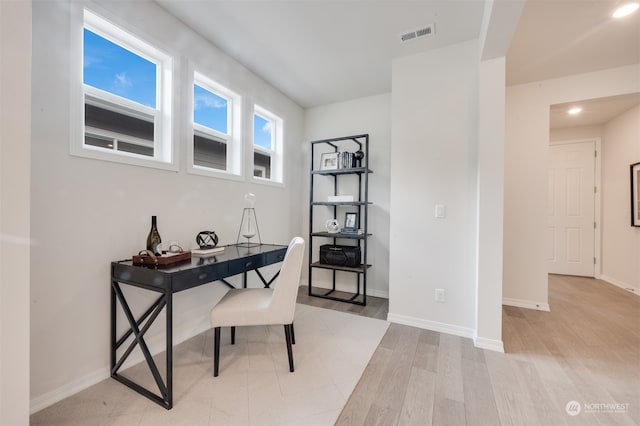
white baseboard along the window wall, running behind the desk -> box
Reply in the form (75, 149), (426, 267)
(29, 321), (210, 414)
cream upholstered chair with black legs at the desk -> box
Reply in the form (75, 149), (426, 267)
(210, 237), (304, 377)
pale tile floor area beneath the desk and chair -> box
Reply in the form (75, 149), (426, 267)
(30, 304), (388, 426)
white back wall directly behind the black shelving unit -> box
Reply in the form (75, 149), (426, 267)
(303, 93), (391, 297)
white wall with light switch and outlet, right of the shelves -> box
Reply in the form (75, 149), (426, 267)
(389, 40), (479, 337)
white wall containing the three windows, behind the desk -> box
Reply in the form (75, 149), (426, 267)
(31, 0), (307, 410)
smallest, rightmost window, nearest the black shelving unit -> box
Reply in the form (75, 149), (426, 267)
(253, 105), (283, 183)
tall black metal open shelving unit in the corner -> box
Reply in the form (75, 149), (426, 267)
(308, 134), (372, 305)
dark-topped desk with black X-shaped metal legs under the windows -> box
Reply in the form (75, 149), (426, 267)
(111, 244), (287, 409)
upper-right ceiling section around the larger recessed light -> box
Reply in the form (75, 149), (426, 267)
(507, 0), (640, 86)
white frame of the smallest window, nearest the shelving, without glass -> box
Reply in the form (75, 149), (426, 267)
(249, 104), (284, 186)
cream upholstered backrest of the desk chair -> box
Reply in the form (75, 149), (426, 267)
(269, 237), (304, 324)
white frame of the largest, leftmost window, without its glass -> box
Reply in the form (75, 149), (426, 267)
(70, 6), (178, 171)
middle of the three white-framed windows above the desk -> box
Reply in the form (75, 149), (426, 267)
(189, 72), (242, 176)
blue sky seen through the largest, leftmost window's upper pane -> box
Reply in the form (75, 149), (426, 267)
(83, 28), (157, 108)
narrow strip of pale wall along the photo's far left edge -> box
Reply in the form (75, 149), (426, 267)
(0, 1), (31, 426)
